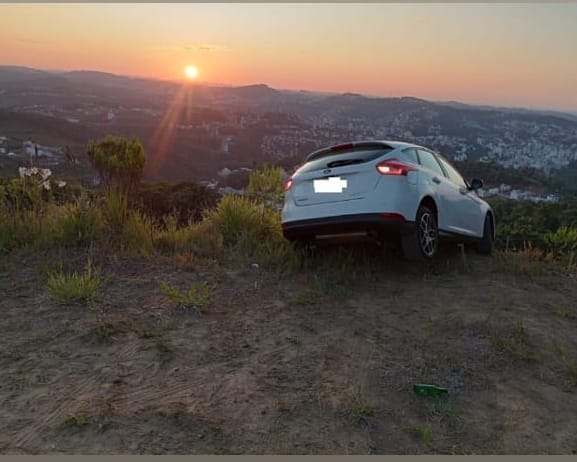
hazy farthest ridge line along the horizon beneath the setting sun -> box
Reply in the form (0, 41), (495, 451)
(0, 66), (577, 121)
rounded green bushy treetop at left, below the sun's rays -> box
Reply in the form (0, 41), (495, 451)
(87, 135), (146, 192)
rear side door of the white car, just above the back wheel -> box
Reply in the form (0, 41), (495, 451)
(417, 149), (461, 233)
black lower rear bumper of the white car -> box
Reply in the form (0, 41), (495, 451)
(282, 213), (415, 241)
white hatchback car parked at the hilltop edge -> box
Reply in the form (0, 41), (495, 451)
(281, 141), (495, 259)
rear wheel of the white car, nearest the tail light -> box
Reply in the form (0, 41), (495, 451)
(401, 205), (439, 260)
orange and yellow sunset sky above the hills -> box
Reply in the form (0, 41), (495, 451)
(0, 3), (577, 111)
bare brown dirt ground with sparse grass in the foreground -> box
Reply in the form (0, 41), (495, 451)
(0, 245), (577, 454)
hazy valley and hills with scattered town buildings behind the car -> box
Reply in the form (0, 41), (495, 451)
(0, 67), (577, 202)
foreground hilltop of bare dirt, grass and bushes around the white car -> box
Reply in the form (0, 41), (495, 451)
(0, 156), (577, 454)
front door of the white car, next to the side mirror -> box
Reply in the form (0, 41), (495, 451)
(437, 155), (485, 237)
